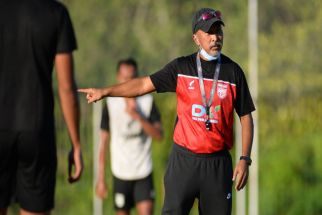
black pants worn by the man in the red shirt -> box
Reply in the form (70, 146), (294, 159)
(162, 144), (233, 215)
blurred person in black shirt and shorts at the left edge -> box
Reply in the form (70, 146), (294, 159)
(0, 0), (83, 215)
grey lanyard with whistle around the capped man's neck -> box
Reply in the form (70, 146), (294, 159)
(196, 52), (221, 120)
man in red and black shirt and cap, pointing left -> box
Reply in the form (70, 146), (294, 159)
(79, 8), (255, 215)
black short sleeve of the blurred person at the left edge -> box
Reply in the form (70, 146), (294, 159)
(56, 7), (77, 53)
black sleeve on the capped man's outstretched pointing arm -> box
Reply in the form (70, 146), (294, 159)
(150, 59), (178, 93)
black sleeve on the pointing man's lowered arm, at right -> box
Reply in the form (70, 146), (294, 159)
(235, 65), (255, 116)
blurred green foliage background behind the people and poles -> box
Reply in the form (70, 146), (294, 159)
(10, 0), (322, 215)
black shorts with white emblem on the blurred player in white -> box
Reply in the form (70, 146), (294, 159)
(113, 174), (155, 211)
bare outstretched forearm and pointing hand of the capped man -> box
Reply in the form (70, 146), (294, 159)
(78, 76), (155, 103)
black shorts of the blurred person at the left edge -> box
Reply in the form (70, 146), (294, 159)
(0, 131), (57, 212)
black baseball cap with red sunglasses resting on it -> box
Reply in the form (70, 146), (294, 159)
(192, 8), (225, 34)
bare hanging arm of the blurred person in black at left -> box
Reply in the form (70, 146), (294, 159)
(55, 53), (83, 182)
